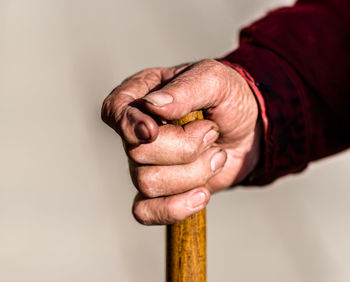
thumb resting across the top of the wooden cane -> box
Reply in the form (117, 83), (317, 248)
(143, 60), (229, 120)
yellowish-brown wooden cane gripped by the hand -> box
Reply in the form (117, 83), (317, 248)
(166, 111), (206, 282)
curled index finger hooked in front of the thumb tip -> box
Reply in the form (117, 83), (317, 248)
(101, 65), (190, 145)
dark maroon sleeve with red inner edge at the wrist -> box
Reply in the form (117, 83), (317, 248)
(224, 0), (350, 185)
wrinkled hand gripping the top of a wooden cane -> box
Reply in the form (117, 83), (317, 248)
(102, 60), (262, 225)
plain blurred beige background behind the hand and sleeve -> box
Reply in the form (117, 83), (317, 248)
(0, 0), (350, 282)
